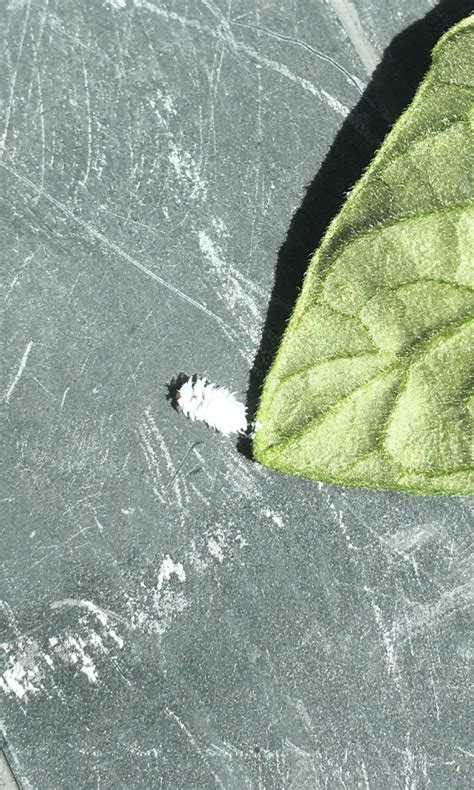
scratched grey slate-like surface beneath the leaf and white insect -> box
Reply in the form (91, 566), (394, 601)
(0, 0), (473, 790)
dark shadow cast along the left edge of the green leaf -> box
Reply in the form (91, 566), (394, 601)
(238, 0), (472, 458)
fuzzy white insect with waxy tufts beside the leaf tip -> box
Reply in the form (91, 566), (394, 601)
(176, 375), (248, 436)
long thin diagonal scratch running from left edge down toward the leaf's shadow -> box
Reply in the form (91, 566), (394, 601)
(0, 161), (235, 341)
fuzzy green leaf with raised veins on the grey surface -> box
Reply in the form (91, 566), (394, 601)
(254, 17), (474, 494)
